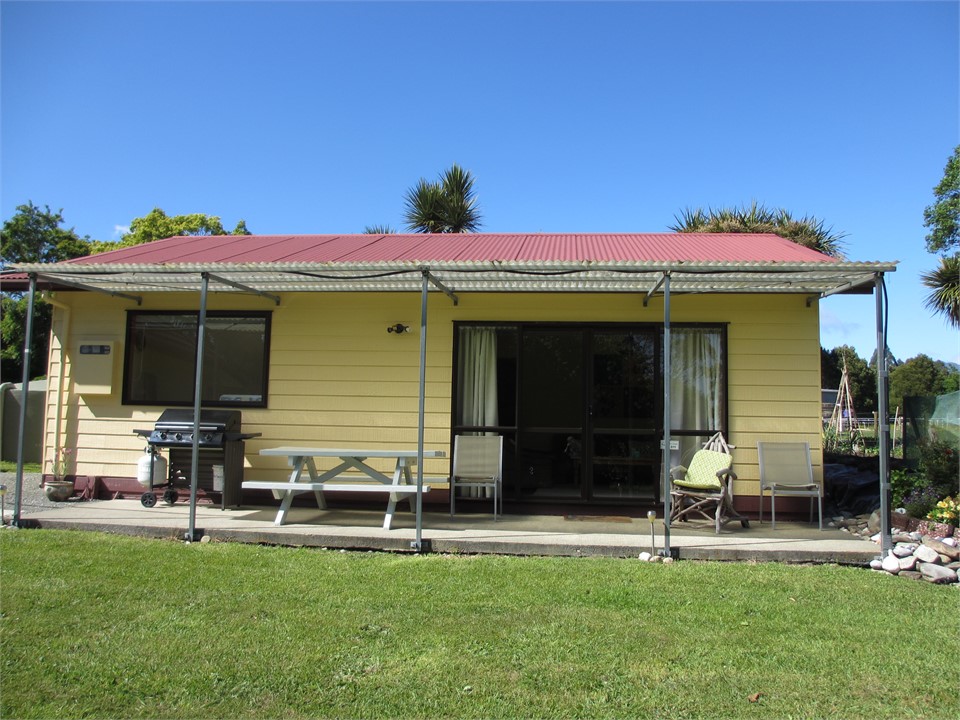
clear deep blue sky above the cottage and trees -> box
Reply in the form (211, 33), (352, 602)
(0, 0), (960, 361)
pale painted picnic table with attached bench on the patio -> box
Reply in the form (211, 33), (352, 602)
(243, 447), (446, 530)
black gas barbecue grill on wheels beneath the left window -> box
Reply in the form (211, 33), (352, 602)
(134, 408), (260, 509)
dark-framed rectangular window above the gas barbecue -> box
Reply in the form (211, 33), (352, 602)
(123, 312), (270, 407)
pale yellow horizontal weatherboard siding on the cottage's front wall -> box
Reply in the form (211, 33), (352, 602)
(44, 292), (821, 495)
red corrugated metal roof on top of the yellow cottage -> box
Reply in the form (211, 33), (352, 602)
(65, 233), (835, 264)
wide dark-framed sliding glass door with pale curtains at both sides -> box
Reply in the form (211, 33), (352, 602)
(453, 323), (726, 509)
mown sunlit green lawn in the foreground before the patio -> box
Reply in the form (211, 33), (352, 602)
(0, 530), (960, 720)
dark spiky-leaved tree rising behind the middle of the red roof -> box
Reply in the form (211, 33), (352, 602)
(404, 164), (481, 233)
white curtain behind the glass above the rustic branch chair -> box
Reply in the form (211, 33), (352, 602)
(670, 328), (723, 465)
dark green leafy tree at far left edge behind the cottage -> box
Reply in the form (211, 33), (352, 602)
(0, 201), (93, 382)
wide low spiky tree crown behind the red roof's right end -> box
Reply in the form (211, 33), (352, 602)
(670, 202), (845, 258)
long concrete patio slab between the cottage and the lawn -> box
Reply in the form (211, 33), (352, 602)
(1, 499), (880, 565)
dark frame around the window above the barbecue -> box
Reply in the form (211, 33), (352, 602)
(121, 310), (273, 408)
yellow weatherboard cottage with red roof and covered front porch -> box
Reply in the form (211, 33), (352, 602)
(5, 233), (895, 540)
